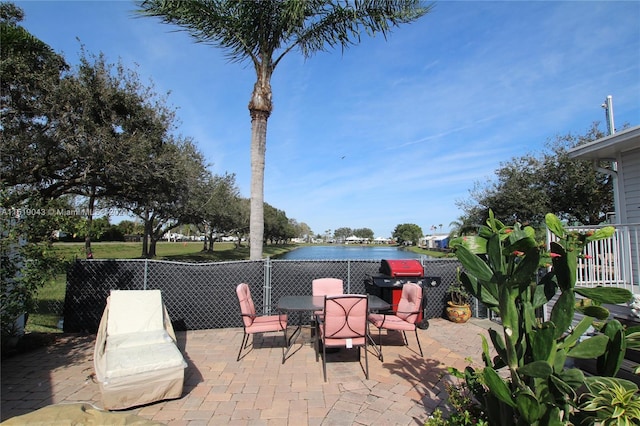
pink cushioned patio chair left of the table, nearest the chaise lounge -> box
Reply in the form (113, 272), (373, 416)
(236, 283), (288, 364)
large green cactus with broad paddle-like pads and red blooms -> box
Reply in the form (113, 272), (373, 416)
(452, 211), (631, 425)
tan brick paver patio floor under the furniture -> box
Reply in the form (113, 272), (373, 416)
(0, 318), (498, 426)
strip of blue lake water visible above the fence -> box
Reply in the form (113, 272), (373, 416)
(278, 245), (422, 260)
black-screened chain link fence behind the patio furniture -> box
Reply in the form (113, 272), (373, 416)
(64, 258), (478, 333)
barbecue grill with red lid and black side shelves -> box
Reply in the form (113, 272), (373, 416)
(364, 259), (441, 328)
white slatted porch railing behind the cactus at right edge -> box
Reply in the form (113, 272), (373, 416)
(547, 224), (640, 293)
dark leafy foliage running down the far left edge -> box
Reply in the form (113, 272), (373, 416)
(0, 3), (68, 342)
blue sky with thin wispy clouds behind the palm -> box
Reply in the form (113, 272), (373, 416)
(16, 1), (640, 237)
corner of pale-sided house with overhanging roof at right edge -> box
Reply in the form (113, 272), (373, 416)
(569, 126), (640, 293)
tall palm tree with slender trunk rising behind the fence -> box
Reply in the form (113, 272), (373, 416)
(138, 0), (432, 260)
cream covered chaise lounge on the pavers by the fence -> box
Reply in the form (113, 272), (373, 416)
(93, 290), (187, 410)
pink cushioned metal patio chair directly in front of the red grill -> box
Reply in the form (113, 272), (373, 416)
(369, 283), (423, 361)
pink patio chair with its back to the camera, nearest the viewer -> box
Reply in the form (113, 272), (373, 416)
(315, 294), (369, 382)
